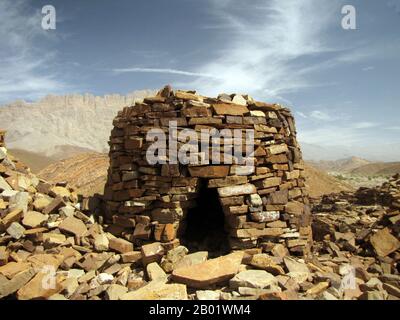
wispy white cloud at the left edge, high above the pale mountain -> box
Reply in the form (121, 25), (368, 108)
(0, 0), (66, 102)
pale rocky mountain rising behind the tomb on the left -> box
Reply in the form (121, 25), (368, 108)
(0, 90), (155, 159)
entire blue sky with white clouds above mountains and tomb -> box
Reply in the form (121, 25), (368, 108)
(0, 0), (400, 160)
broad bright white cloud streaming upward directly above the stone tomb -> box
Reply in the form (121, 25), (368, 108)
(177, 0), (337, 98)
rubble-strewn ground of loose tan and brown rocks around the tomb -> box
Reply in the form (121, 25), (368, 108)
(0, 144), (400, 300)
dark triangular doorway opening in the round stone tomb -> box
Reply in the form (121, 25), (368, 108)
(181, 180), (230, 257)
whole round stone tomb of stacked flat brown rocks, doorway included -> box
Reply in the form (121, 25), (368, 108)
(104, 86), (312, 255)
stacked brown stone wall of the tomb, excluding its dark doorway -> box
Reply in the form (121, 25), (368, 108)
(105, 86), (312, 255)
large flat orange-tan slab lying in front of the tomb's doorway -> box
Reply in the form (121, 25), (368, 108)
(172, 252), (243, 289)
